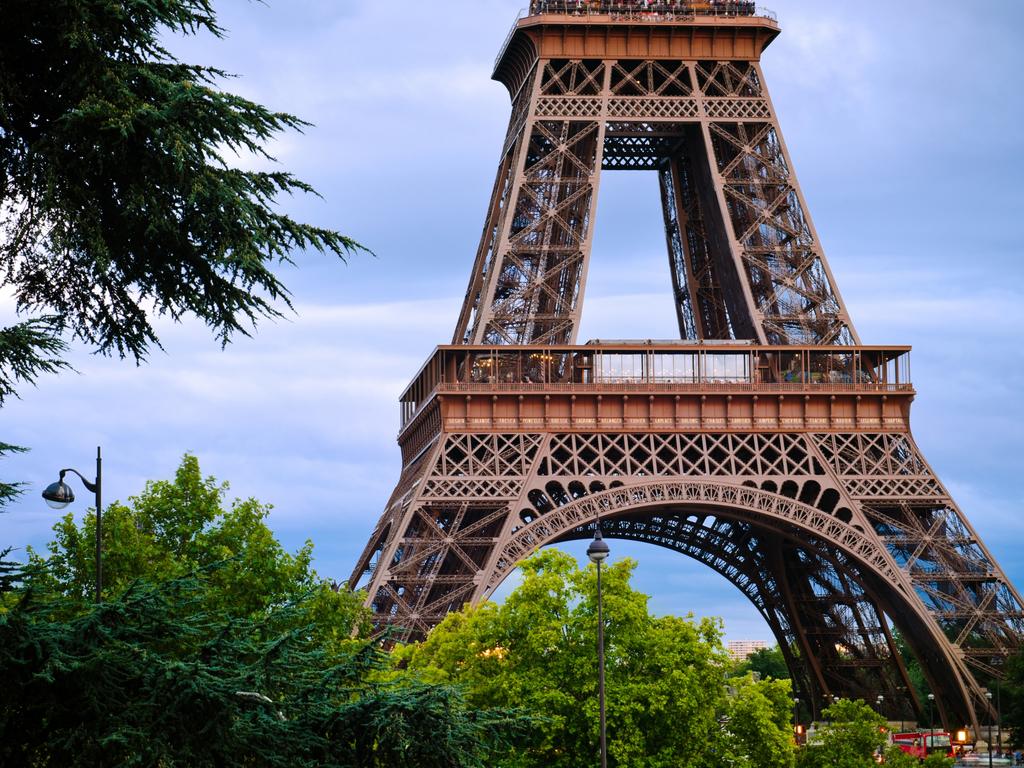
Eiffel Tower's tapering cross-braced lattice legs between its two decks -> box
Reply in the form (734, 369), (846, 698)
(455, 50), (856, 345)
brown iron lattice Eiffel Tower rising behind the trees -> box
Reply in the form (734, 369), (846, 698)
(350, 0), (1024, 728)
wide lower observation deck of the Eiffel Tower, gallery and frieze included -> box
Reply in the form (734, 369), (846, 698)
(399, 340), (915, 459)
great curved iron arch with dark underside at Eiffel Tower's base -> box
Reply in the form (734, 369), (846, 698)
(483, 478), (984, 719)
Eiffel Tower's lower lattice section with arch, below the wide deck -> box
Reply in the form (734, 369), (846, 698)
(353, 417), (1024, 719)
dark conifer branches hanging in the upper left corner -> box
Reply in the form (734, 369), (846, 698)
(0, 0), (361, 504)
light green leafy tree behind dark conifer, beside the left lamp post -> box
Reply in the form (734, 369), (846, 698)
(24, 455), (368, 645)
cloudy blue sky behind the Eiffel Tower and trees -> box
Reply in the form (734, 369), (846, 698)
(0, 0), (1024, 639)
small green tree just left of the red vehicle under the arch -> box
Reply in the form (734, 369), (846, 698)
(797, 699), (887, 768)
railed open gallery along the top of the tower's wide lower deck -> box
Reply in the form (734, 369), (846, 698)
(401, 341), (913, 434)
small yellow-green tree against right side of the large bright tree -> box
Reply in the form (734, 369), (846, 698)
(723, 675), (795, 768)
